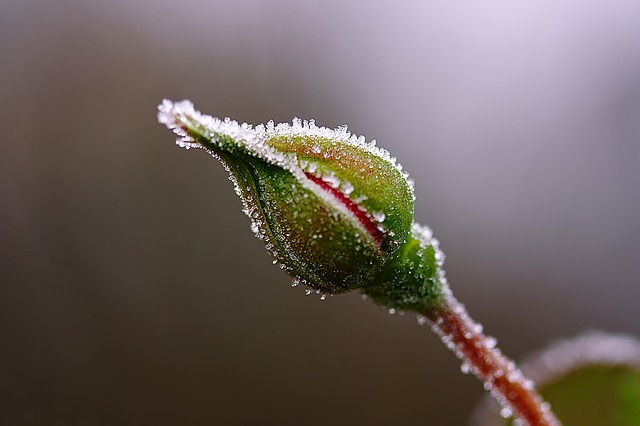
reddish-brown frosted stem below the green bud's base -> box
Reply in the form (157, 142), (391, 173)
(425, 294), (560, 426)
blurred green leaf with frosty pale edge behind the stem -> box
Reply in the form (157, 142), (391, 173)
(472, 333), (640, 426)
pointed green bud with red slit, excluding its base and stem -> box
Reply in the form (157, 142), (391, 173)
(158, 100), (414, 293)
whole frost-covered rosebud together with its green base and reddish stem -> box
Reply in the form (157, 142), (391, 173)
(158, 100), (560, 426)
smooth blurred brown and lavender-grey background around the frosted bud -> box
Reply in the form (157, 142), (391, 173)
(0, 0), (640, 425)
